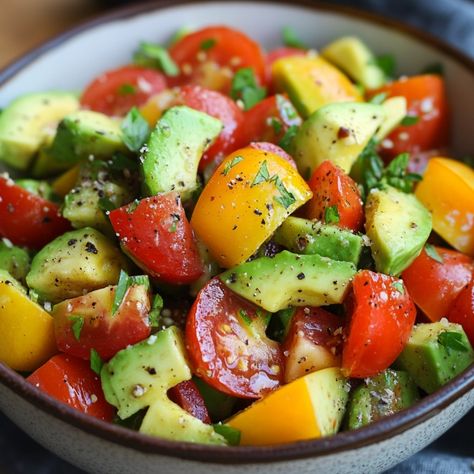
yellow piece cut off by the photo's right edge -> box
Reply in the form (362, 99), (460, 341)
(415, 158), (474, 257)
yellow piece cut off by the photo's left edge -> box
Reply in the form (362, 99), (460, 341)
(0, 278), (57, 372)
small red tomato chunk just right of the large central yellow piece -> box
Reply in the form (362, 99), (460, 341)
(304, 160), (364, 231)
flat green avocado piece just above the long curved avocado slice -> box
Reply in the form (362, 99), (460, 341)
(273, 216), (362, 265)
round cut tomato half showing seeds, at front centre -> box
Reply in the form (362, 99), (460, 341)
(186, 278), (283, 398)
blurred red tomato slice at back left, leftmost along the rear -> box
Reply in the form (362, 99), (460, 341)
(81, 65), (167, 116)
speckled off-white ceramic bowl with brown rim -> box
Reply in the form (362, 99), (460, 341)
(0, 0), (474, 474)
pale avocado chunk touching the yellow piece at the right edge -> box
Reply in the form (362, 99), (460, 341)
(365, 186), (431, 275)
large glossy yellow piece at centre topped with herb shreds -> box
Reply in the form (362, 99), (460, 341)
(191, 148), (312, 268)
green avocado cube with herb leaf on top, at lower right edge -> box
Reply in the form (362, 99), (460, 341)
(397, 320), (474, 393)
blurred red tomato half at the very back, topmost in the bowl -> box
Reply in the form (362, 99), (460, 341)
(170, 26), (266, 93)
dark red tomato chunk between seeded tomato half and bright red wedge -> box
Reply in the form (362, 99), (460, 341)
(282, 308), (346, 383)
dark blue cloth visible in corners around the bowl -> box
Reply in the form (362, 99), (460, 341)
(0, 0), (474, 474)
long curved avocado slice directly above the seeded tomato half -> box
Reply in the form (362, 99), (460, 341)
(219, 250), (356, 313)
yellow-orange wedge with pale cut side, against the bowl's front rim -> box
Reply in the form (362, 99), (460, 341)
(226, 368), (349, 445)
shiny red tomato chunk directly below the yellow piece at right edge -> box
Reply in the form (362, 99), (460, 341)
(402, 247), (472, 321)
